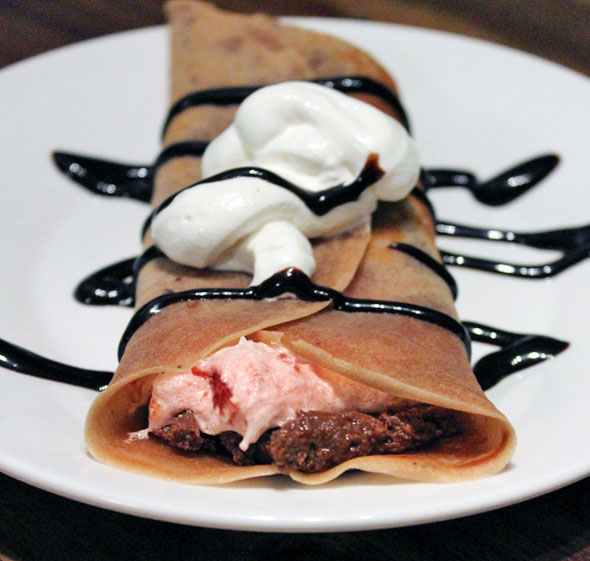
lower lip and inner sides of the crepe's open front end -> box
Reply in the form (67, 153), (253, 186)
(85, 344), (516, 486)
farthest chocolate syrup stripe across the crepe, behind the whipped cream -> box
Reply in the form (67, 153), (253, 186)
(162, 76), (410, 137)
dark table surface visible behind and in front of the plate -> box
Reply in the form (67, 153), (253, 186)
(0, 0), (590, 561)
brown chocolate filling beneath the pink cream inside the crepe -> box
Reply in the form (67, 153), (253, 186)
(150, 404), (459, 473)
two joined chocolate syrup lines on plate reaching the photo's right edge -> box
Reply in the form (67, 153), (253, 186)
(436, 222), (590, 279)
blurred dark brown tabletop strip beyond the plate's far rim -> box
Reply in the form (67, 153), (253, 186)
(0, 0), (590, 75)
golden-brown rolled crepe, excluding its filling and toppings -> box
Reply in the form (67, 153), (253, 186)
(86, 1), (515, 484)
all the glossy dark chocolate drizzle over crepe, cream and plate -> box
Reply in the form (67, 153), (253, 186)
(11, 76), (590, 398)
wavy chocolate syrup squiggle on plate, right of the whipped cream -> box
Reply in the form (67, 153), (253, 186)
(422, 154), (559, 206)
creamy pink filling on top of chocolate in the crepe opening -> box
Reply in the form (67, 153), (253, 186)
(146, 337), (396, 450)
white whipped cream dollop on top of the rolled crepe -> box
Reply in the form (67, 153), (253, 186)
(152, 82), (420, 285)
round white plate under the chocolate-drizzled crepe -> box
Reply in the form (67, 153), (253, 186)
(0, 19), (590, 531)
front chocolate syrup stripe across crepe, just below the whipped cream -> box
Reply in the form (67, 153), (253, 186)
(119, 267), (471, 360)
